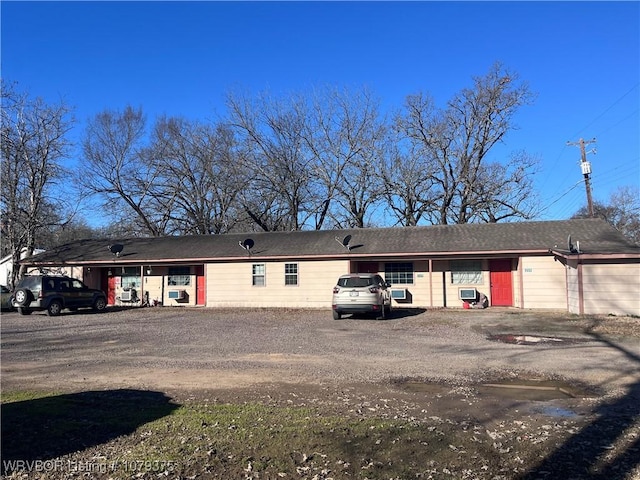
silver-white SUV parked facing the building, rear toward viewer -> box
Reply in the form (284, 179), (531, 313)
(332, 273), (391, 320)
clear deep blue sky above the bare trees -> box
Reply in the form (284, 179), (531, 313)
(0, 0), (640, 220)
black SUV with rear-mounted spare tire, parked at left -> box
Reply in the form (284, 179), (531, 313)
(11, 275), (107, 316)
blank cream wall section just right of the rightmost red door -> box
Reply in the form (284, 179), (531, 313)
(514, 256), (567, 309)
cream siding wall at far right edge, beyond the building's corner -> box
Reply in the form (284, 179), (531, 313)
(582, 263), (640, 315)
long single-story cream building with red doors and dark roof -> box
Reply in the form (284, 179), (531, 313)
(17, 219), (640, 315)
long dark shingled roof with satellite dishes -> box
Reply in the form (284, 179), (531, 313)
(24, 219), (640, 265)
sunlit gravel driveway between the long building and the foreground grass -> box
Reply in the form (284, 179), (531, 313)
(1, 308), (640, 398)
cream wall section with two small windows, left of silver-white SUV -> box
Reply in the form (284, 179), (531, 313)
(206, 260), (349, 308)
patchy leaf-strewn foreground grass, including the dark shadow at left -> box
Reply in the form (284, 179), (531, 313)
(2, 390), (628, 479)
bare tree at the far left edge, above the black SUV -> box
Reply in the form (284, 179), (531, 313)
(0, 82), (73, 287)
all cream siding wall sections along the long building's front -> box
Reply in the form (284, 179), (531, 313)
(72, 256), (640, 315)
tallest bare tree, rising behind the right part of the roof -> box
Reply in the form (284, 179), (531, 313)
(396, 64), (536, 224)
